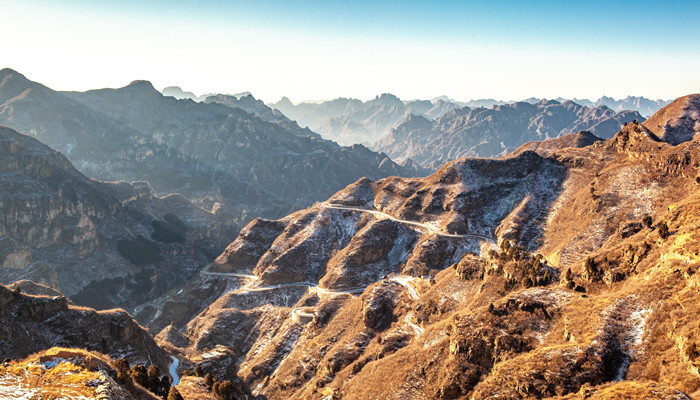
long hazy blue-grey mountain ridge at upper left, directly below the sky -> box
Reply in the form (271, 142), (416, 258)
(0, 69), (423, 225)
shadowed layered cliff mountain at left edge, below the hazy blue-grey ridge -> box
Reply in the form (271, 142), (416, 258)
(0, 127), (236, 308)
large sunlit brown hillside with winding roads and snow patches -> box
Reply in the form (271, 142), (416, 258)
(149, 95), (700, 399)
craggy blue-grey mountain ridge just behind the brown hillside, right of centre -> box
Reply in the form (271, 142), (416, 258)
(373, 100), (644, 168)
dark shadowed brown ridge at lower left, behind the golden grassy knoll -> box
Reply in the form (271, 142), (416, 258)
(0, 285), (170, 371)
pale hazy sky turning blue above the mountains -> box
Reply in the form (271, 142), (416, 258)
(0, 0), (700, 101)
